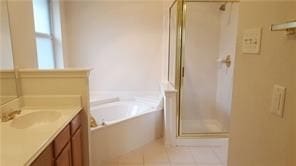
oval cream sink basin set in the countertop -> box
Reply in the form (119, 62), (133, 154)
(11, 111), (61, 129)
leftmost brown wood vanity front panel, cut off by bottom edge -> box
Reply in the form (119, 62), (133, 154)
(30, 144), (54, 166)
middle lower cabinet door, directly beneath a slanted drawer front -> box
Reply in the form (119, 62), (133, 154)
(55, 143), (72, 166)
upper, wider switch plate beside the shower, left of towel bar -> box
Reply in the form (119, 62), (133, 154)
(242, 28), (262, 54)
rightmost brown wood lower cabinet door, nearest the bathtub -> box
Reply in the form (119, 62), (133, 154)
(71, 128), (82, 166)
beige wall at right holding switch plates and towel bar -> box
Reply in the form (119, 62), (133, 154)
(229, 1), (296, 166)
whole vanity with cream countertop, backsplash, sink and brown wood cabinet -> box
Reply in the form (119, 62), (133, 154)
(0, 96), (87, 166)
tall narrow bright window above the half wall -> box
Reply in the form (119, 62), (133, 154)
(33, 0), (55, 69)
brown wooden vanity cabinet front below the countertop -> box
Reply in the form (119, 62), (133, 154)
(31, 113), (83, 166)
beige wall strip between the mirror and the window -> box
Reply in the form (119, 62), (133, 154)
(8, 0), (37, 68)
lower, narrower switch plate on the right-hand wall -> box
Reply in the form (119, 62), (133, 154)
(271, 85), (286, 117)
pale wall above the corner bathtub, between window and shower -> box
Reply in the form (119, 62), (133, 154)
(63, 0), (164, 92)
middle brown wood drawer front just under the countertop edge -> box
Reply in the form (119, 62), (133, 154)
(53, 125), (70, 158)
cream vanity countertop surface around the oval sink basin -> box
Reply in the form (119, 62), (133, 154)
(0, 106), (82, 166)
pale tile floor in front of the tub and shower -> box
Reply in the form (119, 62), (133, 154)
(103, 139), (227, 166)
